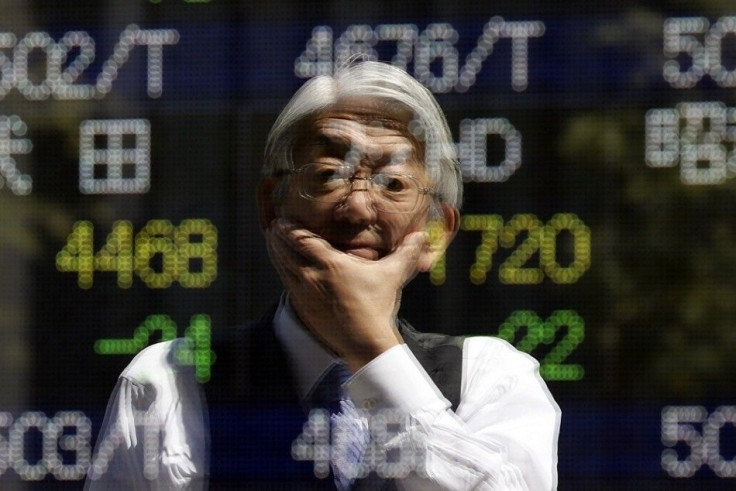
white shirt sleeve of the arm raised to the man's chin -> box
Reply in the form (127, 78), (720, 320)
(346, 337), (560, 490)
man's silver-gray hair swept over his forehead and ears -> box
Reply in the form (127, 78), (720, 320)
(262, 61), (462, 208)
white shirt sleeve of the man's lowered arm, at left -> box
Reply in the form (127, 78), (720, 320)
(85, 340), (207, 491)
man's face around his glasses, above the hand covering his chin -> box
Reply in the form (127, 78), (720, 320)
(276, 101), (431, 260)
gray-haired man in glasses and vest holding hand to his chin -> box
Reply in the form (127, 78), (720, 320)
(88, 62), (560, 490)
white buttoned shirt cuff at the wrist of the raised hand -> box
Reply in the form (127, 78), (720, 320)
(345, 344), (450, 414)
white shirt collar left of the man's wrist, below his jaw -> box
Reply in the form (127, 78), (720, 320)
(273, 292), (342, 399)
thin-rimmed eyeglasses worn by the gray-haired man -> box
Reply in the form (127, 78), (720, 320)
(290, 163), (434, 213)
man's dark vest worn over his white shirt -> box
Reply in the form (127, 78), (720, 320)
(205, 311), (463, 490)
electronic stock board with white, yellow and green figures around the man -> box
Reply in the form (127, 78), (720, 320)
(0, 0), (736, 490)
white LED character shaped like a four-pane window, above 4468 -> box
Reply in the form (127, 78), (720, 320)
(79, 119), (151, 194)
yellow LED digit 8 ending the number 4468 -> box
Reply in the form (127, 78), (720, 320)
(174, 218), (217, 288)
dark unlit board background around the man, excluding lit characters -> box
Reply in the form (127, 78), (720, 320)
(0, 0), (736, 489)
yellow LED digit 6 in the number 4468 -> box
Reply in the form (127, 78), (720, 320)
(135, 220), (177, 288)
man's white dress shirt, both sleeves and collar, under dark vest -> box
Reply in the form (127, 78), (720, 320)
(87, 299), (561, 491)
